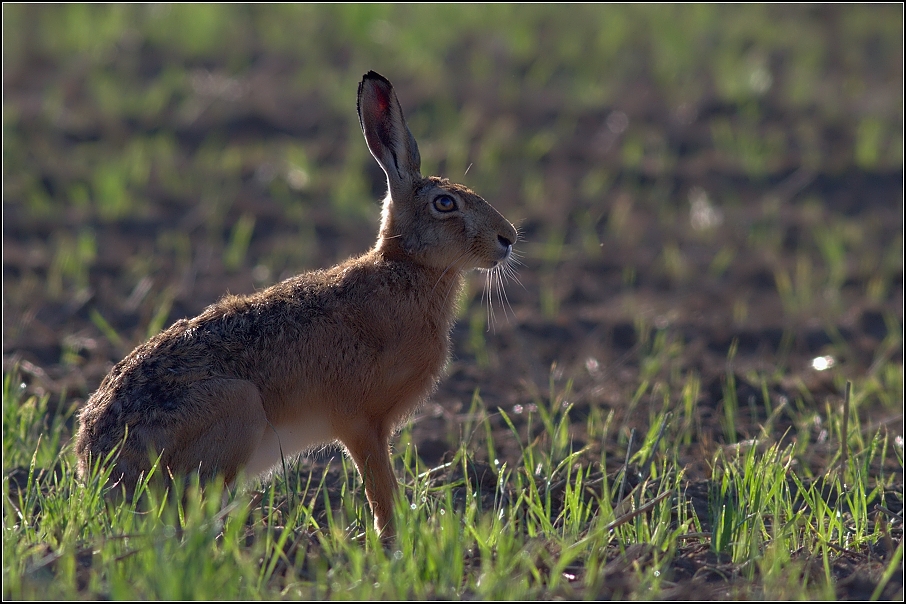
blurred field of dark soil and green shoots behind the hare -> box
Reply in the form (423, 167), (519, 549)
(3, 4), (903, 462)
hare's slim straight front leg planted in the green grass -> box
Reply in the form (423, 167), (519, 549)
(340, 426), (398, 537)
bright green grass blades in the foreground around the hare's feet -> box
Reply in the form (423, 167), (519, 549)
(3, 364), (903, 599)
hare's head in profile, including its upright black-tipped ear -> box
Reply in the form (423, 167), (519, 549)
(358, 71), (516, 270)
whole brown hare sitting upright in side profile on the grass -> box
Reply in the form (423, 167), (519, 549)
(76, 71), (516, 534)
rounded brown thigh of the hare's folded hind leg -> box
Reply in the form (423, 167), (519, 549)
(165, 378), (267, 484)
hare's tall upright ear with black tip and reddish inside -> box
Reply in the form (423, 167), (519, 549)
(358, 71), (421, 191)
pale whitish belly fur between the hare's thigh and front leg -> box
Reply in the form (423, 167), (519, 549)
(245, 416), (336, 477)
